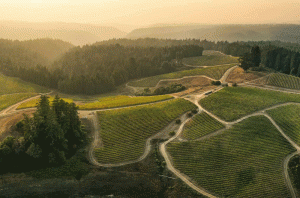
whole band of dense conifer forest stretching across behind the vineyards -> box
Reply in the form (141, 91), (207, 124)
(0, 38), (300, 94)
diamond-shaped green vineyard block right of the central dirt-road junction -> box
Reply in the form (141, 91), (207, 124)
(200, 87), (300, 121)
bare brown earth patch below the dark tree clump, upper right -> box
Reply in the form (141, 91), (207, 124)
(226, 67), (266, 83)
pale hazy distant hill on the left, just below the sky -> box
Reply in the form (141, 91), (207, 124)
(0, 21), (126, 45)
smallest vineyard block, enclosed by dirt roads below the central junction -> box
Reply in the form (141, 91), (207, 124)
(183, 112), (224, 140)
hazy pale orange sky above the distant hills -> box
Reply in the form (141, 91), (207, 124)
(0, 0), (300, 26)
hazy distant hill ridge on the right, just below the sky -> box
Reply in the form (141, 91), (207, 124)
(126, 24), (300, 42)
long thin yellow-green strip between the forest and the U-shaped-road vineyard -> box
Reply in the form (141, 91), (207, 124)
(78, 95), (173, 110)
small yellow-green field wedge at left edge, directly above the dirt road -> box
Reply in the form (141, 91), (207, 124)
(0, 93), (37, 110)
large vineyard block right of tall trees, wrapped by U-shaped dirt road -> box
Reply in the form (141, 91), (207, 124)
(94, 99), (197, 163)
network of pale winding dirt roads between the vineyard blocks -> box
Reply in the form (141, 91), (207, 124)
(0, 66), (300, 198)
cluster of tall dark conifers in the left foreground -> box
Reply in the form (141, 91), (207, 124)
(0, 96), (87, 172)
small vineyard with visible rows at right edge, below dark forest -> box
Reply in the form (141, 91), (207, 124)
(267, 73), (300, 89)
